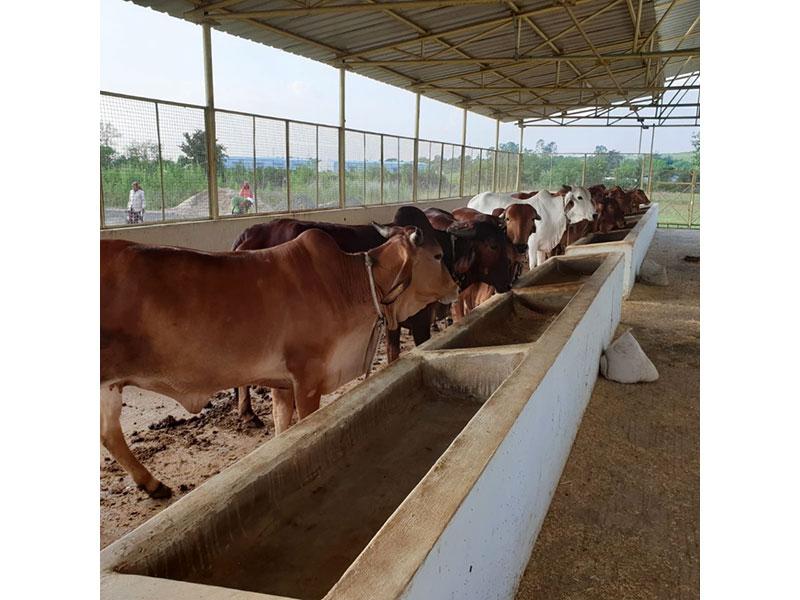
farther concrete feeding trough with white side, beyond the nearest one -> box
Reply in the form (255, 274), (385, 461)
(566, 203), (658, 298)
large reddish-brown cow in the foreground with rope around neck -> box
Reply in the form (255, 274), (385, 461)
(100, 227), (457, 498)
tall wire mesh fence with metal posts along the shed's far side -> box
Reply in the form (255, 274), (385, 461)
(100, 92), (700, 227)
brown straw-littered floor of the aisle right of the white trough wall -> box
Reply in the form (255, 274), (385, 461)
(516, 229), (700, 600)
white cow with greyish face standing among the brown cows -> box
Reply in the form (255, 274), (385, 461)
(467, 186), (595, 268)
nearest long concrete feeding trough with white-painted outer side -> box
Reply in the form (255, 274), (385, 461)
(101, 254), (623, 600)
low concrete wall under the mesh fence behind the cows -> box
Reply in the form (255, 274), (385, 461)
(100, 196), (470, 252)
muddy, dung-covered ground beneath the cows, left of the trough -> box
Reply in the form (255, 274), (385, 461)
(100, 323), (428, 548)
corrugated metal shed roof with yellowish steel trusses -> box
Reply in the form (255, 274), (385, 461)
(123, 0), (700, 121)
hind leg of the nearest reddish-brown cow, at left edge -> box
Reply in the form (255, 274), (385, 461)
(100, 386), (172, 498)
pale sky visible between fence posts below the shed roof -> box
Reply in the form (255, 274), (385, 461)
(100, 0), (696, 153)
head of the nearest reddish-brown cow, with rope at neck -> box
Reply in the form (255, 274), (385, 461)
(369, 223), (458, 329)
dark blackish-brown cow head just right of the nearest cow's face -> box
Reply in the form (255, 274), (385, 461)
(447, 221), (514, 292)
